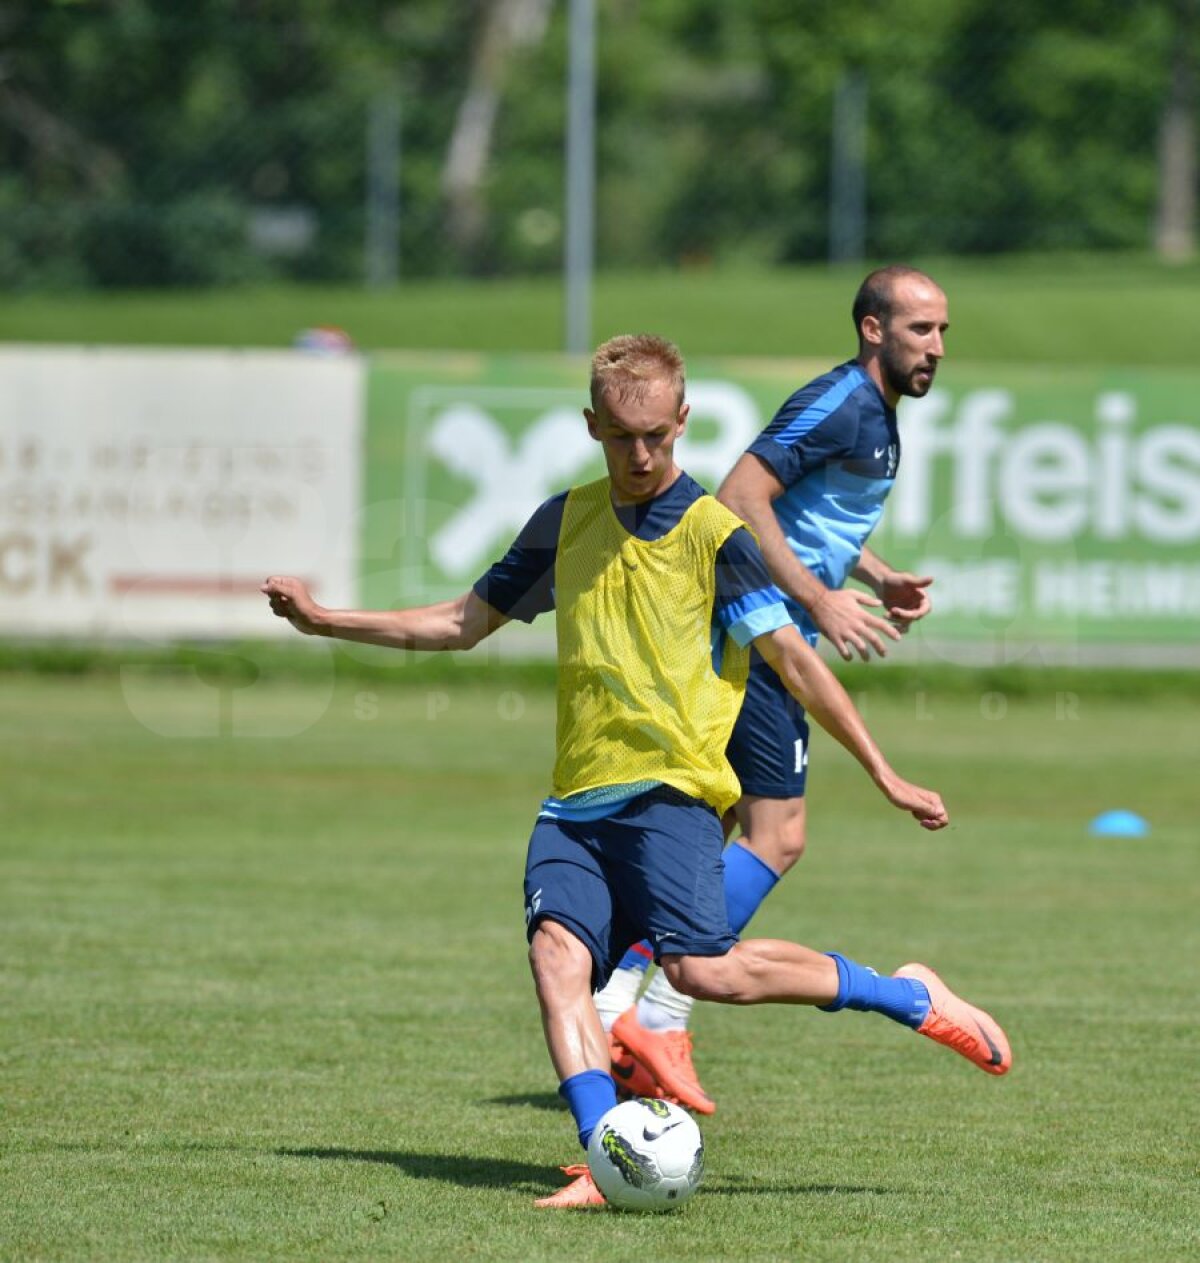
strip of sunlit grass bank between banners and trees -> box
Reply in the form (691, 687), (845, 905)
(0, 248), (1200, 368)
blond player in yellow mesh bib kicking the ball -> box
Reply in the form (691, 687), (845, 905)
(263, 335), (1012, 1207)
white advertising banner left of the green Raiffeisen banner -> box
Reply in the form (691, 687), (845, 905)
(0, 346), (364, 639)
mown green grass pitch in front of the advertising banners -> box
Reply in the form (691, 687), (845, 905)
(0, 674), (1200, 1263)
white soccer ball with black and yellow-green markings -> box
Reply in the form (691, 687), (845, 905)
(587, 1096), (704, 1210)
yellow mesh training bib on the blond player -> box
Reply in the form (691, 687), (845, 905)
(553, 479), (749, 812)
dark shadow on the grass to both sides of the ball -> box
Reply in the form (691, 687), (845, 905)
(275, 1148), (904, 1197)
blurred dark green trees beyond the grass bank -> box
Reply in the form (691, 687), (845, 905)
(0, 0), (1200, 289)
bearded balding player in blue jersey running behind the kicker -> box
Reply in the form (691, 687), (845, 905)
(596, 266), (947, 1114)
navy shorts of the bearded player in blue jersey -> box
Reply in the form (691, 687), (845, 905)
(725, 653), (808, 798)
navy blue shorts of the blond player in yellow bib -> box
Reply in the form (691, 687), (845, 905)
(525, 786), (738, 989)
